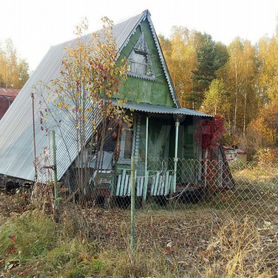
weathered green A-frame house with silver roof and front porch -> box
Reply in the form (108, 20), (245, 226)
(0, 10), (231, 198)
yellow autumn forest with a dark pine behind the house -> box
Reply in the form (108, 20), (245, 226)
(0, 26), (278, 159)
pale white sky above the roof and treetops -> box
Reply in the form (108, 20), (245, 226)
(0, 0), (278, 71)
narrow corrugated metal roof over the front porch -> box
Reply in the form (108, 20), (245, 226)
(116, 103), (213, 118)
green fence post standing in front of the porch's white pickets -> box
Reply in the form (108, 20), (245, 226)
(130, 155), (136, 265)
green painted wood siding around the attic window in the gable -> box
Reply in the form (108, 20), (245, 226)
(116, 21), (175, 107)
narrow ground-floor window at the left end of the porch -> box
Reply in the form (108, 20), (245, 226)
(120, 125), (133, 162)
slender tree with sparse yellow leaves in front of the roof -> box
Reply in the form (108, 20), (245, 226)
(37, 18), (129, 200)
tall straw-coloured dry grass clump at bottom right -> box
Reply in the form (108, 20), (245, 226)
(203, 218), (277, 278)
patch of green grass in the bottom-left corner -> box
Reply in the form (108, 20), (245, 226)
(0, 210), (105, 277)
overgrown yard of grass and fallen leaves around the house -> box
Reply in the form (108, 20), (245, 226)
(0, 164), (278, 278)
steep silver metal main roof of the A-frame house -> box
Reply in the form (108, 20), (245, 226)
(0, 10), (193, 180)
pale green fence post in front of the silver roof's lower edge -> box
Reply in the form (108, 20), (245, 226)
(51, 130), (60, 222)
